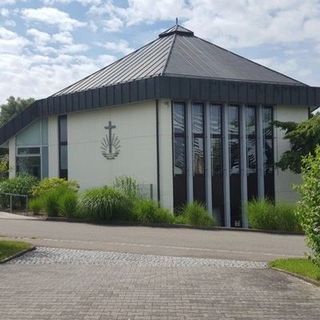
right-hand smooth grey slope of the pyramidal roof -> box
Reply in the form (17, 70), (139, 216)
(164, 35), (303, 85)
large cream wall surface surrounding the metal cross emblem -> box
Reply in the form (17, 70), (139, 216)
(68, 101), (157, 199)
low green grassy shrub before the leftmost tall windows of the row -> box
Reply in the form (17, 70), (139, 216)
(176, 202), (216, 226)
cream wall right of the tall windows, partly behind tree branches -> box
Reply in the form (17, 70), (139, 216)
(274, 106), (308, 202)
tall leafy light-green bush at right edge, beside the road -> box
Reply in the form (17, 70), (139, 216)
(296, 146), (320, 266)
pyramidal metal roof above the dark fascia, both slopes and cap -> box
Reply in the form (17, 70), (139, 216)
(54, 25), (304, 96)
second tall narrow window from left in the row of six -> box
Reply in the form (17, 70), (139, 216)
(192, 103), (206, 204)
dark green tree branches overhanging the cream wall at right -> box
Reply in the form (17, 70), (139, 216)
(274, 114), (320, 173)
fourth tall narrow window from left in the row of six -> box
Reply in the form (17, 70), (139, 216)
(228, 106), (241, 227)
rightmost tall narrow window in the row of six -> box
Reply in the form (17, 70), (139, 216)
(263, 107), (274, 200)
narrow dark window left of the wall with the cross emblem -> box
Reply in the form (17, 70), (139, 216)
(59, 115), (68, 179)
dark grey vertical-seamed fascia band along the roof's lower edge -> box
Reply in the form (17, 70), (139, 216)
(0, 76), (320, 144)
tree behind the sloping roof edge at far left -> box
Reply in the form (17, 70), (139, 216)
(0, 96), (35, 127)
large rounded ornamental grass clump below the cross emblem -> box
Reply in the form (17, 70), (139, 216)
(79, 187), (130, 221)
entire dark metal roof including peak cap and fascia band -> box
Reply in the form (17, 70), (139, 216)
(0, 26), (320, 145)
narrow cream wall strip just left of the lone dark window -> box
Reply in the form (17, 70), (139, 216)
(48, 116), (59, 177)
